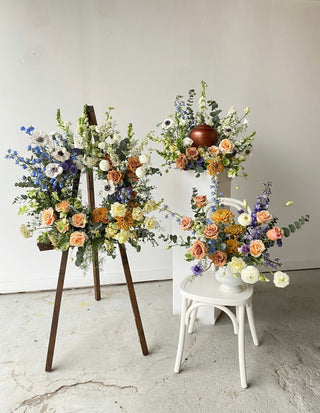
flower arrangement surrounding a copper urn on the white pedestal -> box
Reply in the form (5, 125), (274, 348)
(152, 81), (255, 178)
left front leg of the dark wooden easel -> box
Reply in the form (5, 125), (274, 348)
(45, 250), (69, 371)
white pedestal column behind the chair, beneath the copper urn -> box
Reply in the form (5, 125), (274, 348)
(169, 169), (231, 324)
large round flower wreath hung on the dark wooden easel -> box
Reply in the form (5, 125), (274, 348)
(6, 107), (160, 268)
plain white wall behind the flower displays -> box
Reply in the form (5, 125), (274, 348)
(0, 0), (320, 292)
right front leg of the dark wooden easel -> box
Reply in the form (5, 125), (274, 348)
(119, 244), (149, 356)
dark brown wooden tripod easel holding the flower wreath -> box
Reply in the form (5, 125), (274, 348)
(45, 106), (148, 371)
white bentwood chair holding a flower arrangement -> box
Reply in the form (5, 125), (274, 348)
(174, 198), (259, 389)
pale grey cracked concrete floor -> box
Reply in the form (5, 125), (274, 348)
(0, 270), (320, 413)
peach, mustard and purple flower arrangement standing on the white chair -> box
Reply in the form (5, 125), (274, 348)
(162, 181), (309, 287)
